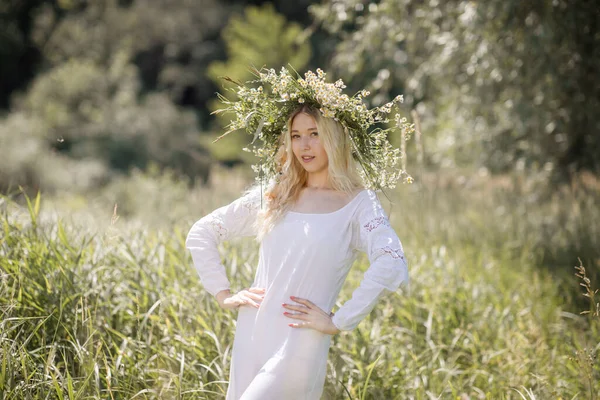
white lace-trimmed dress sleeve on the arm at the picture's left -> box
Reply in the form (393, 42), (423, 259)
(185, 189), (260, 296)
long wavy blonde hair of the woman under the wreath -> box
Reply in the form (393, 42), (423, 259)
(257, 105), (364, 240)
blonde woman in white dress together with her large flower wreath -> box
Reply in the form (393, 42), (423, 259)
(186, 68), (414, 400)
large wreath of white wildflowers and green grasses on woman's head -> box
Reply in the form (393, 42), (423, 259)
(214, 67), (414, 190)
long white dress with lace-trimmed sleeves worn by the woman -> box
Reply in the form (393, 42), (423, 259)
(186, 190), (408, 400)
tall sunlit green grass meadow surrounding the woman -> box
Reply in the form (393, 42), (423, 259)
(0, 168), (600, 400)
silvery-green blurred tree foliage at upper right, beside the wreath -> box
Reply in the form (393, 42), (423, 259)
(311, 0), (600, 177)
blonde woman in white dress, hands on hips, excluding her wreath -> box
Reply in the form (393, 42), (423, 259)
(186, 105), (408, 400)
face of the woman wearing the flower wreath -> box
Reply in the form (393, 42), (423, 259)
(291, 113), (329, 173)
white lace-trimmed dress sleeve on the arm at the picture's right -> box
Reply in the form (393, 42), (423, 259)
(332, 191), (409, 331)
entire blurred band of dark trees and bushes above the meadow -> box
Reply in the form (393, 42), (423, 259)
(0, 0), (600, 191)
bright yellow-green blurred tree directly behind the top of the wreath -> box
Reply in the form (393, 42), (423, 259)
(207, 3), (311, 161)
